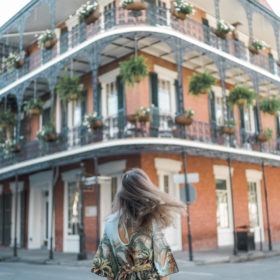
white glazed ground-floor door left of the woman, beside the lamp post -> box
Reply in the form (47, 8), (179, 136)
(63, 181), (80, 253)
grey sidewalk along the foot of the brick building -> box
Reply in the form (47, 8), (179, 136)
(0, 244), (280, 267)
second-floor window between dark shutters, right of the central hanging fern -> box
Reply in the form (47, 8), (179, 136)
(158, 79), (172, 114)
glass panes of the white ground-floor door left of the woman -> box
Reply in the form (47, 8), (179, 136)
(67, 182), (79, 235)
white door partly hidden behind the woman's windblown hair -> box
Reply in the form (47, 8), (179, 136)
(159, 173), (182, 251)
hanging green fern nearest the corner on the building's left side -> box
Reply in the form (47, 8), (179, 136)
(56, 75), (84, 102)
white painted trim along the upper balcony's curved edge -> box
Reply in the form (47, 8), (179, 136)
(0, 26), (280, 96)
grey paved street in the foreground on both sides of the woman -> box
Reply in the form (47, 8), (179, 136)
(0, 257), (280, 280)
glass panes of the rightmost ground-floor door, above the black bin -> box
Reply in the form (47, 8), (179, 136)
(248, 182), (260, 228)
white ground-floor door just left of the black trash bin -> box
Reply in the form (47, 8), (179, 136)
(216, 179), (233, 246)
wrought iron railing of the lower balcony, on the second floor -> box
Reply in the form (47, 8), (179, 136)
(0, 110), (280, 168)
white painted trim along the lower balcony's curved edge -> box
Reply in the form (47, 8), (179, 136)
(0, 137), (280, 175)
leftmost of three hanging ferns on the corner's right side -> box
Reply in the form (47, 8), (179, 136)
(189, 72), (216, 95)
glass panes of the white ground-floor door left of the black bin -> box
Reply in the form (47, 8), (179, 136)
(216, 179), (230, 228)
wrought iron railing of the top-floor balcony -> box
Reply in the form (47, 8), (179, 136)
(0, 6), (280, 87)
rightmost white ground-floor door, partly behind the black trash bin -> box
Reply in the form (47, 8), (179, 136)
(248, 182), (264, 242)
